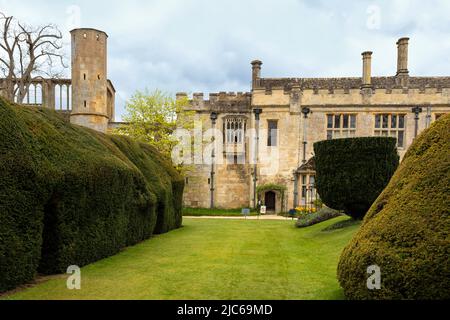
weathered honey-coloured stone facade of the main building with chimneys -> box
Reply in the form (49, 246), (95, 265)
(179, 38), (450, 212)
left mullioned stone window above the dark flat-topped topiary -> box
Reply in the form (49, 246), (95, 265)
(325, 112), (358, 140)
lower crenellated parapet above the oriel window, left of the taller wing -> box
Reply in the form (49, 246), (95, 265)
(177, 92), (252, 113)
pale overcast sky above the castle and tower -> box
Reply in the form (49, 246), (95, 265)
(0, 0), (450, 120)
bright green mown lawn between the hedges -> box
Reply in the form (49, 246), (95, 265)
(3, 217), (358, 300)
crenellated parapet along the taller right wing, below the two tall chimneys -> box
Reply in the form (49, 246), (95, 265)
(252, 77), (450, 109)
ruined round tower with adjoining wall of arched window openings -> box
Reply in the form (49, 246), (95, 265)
(0, 28), (116, 132)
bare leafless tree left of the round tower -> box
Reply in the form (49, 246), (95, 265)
(0, 12), (67, 103)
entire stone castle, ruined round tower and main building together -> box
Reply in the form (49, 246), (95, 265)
(0, 28), (450, 212)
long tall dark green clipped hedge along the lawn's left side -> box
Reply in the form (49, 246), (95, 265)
(0, 99), (184, 292)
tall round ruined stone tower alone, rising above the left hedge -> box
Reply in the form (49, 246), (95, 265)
(70, 29), (112, 132)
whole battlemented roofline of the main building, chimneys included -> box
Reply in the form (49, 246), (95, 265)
(178, 38), (450, 110)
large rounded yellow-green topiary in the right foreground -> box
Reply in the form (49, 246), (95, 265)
(338, 115), (450, 299)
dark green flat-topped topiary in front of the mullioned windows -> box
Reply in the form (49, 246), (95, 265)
(314, 137), (399, 219)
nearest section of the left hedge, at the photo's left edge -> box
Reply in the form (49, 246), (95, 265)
(0, 102), (45, 292)
